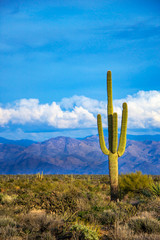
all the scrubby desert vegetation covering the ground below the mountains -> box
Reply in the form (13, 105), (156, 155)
(0, 172), (160, 240)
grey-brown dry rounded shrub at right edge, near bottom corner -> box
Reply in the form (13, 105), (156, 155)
(128, 217), (160, 234)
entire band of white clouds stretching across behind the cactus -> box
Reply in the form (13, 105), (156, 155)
(0, 91), (160, 129)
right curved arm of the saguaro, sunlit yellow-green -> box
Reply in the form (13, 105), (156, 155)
(118, 103), (128, 157)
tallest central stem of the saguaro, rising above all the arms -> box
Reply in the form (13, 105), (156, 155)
(107, 71), (113, 151)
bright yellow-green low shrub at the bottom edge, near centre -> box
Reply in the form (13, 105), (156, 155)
(70, 223), (99, 240)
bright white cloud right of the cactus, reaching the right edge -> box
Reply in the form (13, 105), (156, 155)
(115, 91), (160, 129)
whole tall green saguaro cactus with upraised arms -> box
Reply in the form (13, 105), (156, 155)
(97, 71), (128, 201)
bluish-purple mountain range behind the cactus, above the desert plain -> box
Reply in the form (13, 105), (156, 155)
(0, 136), (160, 174)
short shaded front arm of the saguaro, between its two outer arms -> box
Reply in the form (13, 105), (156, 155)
(112, 113), (118, 153)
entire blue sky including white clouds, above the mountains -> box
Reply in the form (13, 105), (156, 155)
(0, 0), (160, 140)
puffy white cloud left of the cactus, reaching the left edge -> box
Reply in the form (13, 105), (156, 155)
(0, 99), (96, 128)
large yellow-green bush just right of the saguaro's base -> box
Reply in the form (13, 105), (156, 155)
(119, 171), (153, 196)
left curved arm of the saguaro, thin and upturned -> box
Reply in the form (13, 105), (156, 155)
(97, 114), (109, 155)
